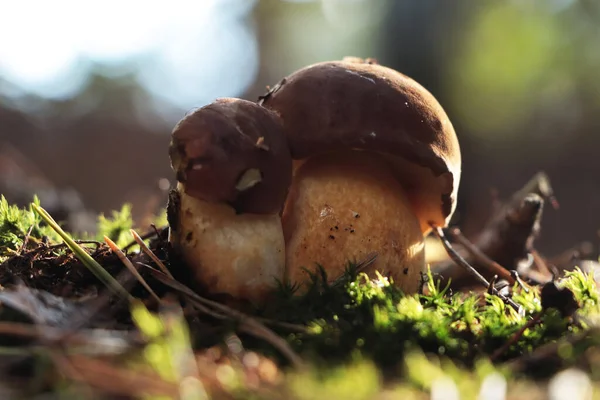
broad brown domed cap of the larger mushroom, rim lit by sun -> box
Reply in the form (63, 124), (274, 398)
(259, 58), (461, 232)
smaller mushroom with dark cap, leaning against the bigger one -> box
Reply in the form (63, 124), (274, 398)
(168, 98), (292, 303)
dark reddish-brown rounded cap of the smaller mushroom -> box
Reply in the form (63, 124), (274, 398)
(169, 98), (292, 214)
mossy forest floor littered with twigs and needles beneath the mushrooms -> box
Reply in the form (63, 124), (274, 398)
(0, 175), (600, 399)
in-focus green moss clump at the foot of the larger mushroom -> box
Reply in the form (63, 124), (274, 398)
(260, 270), (598, 369)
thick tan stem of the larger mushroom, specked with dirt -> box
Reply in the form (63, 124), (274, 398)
(283, 151), (425, 293)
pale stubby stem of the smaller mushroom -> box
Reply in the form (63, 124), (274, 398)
(169, 184), (285, 303)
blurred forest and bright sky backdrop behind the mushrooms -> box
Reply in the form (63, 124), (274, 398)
(0, 0), (600, 254)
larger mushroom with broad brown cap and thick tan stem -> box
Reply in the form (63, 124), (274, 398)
(259, 58), (461, 293)
